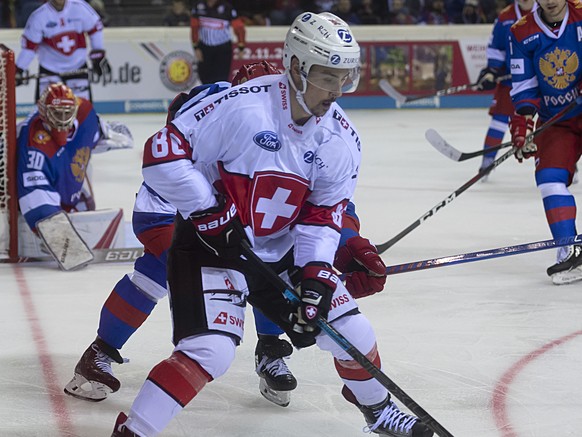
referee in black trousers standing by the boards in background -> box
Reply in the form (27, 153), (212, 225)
(190, 0), (245, 83)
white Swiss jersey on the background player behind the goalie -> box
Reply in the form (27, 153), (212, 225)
(16, 0), (103, 73)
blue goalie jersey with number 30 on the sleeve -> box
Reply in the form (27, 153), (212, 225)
(16, 99), (101, 229)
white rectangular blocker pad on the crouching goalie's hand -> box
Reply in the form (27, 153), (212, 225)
(36, 211), (93, 271)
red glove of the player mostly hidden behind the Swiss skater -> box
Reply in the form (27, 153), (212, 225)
(333, 235), (386, 299)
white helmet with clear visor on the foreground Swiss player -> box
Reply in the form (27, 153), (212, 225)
(283, 12), (360, 93)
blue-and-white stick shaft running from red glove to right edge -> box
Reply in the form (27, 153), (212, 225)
(378, 234), (582, 279)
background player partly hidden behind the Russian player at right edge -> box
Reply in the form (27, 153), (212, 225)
(477, 0), (537, 174)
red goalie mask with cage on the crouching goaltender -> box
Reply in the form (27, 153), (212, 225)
(38, 83), (79, 146)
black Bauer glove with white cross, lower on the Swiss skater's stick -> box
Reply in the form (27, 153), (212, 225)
(289, 262), (339, 333)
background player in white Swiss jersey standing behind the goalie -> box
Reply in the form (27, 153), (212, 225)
(16, 0), (111, 100)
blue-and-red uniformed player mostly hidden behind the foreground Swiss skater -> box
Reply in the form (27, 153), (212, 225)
(65, 61), (386, 412)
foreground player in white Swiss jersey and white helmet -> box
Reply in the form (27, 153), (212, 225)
(113, 12), (433, 437)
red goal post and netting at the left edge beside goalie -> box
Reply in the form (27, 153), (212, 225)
(0, 44), (18, 260)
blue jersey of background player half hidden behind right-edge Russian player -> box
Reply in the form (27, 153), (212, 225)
(487, 1), (537, 86)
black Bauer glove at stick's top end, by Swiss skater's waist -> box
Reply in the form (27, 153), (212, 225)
(190, 194), (247, 260)
